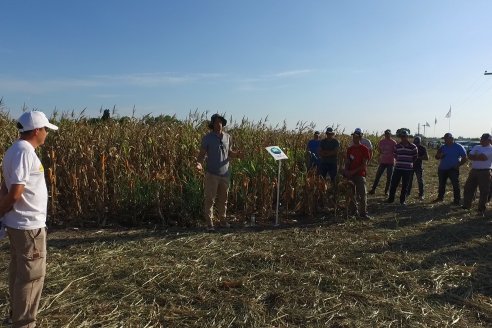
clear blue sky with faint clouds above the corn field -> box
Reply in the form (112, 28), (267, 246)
(0, 0), (492, 137)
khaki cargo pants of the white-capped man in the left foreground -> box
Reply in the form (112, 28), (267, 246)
(7, 228), (46, 328)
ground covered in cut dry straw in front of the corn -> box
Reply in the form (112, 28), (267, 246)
(0, 204), (492, 327)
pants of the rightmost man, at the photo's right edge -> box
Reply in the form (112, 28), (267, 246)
(463, 169), (491, 211)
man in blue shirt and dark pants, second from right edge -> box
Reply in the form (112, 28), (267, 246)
(434, 132), (467, 205)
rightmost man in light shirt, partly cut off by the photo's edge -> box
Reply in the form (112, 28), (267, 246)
(463, 133), (492, 216)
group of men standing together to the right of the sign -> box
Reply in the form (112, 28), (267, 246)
(306, 128), (492, 219)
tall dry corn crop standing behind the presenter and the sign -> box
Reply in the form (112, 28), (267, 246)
(0, 105), (380, 226)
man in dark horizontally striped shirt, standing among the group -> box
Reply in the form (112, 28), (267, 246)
(387, 129), (418, 205)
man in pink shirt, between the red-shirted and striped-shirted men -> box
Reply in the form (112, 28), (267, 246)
(369, 129), (396, 195)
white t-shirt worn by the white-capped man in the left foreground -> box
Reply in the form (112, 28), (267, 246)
(2, 140), (48, 230)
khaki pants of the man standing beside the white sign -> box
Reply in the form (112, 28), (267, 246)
(203, 172), (229, 227)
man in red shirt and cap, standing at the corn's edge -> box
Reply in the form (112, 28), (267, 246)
(344, 130), (371, 220)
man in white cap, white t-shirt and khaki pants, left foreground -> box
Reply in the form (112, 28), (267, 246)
(0, 111), (58, 327)
